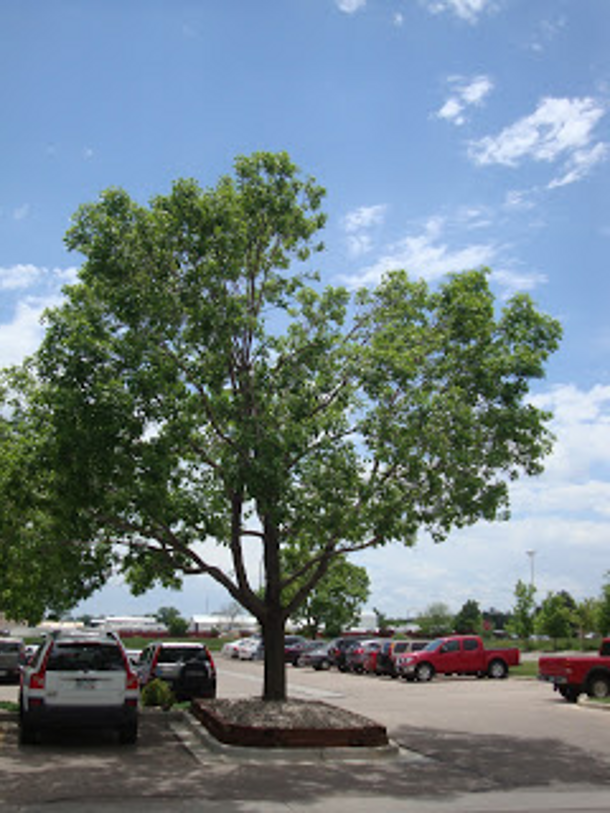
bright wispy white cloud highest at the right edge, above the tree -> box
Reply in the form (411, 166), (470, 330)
(469, 98), (608, 186)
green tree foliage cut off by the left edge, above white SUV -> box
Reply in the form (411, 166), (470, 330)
(0, 366), (112, 625)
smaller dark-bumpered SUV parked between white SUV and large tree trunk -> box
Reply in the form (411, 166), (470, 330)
(138, 641), (216, 700)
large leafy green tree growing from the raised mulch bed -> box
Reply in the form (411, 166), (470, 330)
(14, 153), (561, 700)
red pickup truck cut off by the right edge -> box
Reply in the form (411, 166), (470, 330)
(538, 638), (610, 703)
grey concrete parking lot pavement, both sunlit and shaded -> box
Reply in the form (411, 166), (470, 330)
(0, 657), (610, 813)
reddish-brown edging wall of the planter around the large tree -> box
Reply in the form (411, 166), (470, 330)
(191, 700), (389, 748)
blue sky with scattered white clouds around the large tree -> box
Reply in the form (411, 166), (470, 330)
(0, 0), (610, 615)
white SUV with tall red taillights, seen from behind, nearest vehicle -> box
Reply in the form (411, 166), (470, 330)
(19, 632), (139, 744)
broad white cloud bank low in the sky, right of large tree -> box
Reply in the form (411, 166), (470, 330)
(356, 384), (610, 615)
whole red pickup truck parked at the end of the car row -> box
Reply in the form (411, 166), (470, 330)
(396, 635), (520, 680)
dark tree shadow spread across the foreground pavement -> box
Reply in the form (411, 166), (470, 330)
(0, 713), (610, 813)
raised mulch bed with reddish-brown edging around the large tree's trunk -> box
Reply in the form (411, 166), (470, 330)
(191, 698), (389, 748)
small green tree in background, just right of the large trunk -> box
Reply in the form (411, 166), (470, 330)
(287, 557), (370, 638)
